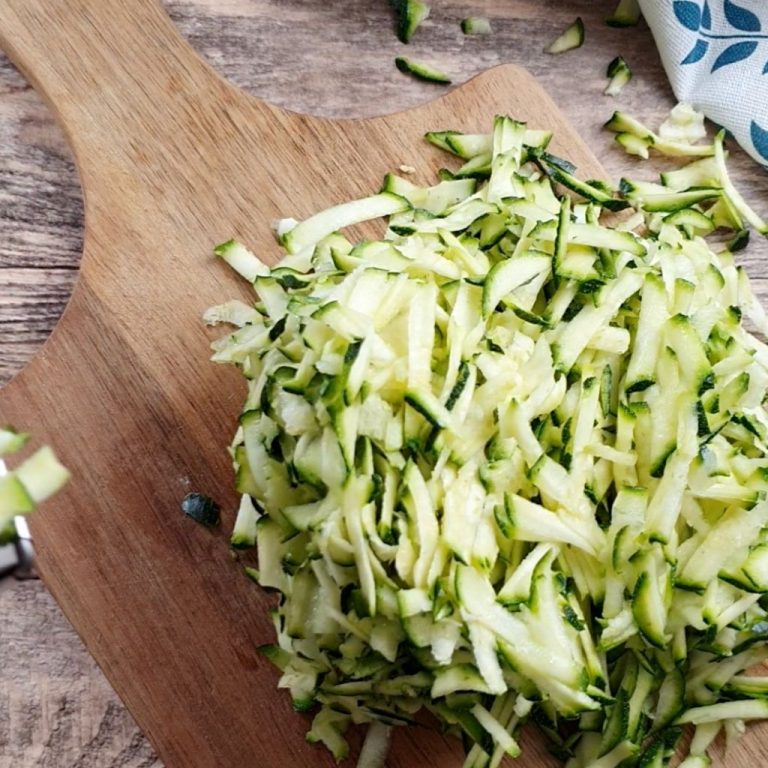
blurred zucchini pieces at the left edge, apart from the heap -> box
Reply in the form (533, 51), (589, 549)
(0, 427), (69, 545)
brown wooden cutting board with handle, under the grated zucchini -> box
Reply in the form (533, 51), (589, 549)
(0, 0), (756, 768)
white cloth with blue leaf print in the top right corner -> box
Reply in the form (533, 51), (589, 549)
(640, 0), (768, 167)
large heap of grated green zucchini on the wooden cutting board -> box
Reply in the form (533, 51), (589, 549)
(206, 116), (768, 768)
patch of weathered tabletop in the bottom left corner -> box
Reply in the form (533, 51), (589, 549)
(0, 582), (161, 768)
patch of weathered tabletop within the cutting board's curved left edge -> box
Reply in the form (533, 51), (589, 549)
(0, 54), (83, 388)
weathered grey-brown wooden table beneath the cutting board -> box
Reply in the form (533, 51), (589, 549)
(0, 0), (768, 768)
